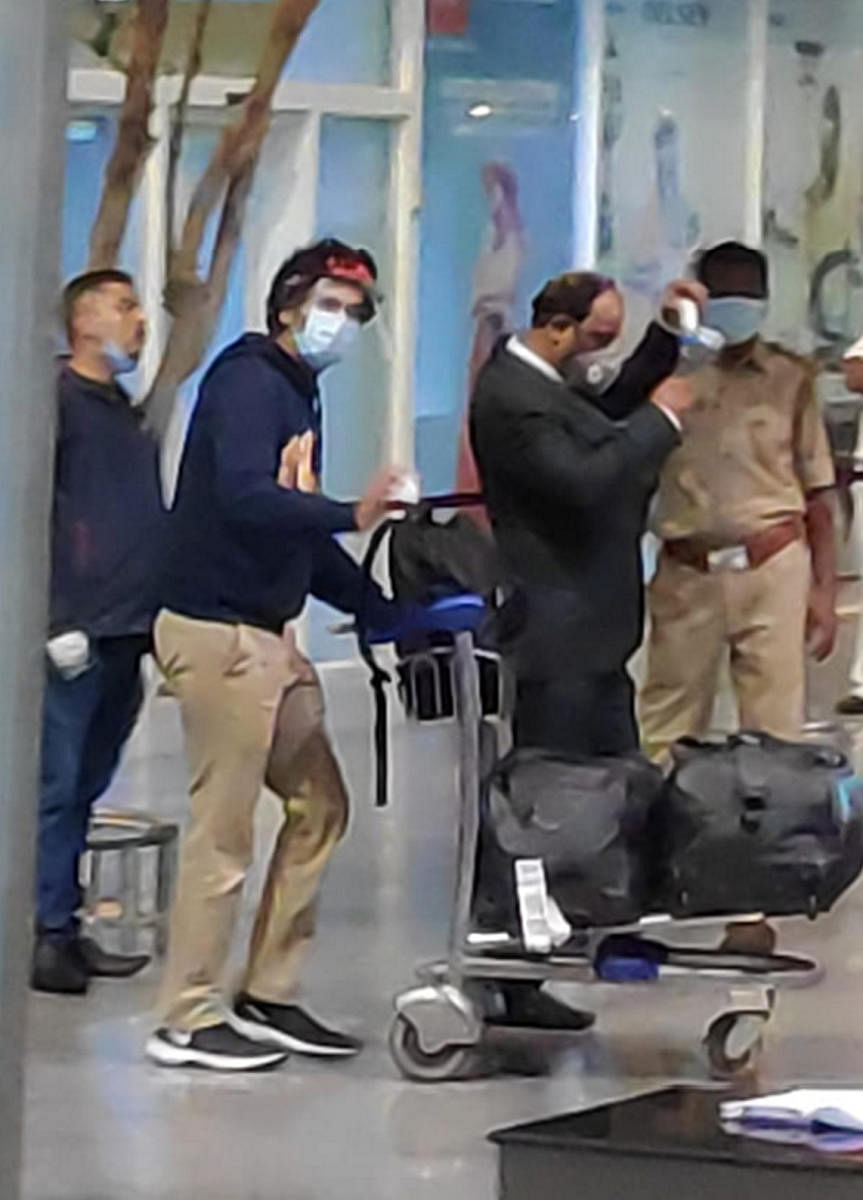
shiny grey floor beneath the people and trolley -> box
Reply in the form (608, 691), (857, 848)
(24, 609), (863, 1200)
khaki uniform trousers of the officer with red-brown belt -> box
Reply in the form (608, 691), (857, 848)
(639, 541), (810, 761)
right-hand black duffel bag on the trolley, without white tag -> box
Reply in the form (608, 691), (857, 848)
(657, 733), (863, 918)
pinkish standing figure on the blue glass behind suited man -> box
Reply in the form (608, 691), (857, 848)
(456, 162), (526, 501)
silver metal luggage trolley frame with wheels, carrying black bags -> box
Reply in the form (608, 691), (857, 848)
(389, 614), (819, 1082)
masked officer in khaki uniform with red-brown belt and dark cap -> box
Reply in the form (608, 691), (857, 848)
(640, 242), (837, 758)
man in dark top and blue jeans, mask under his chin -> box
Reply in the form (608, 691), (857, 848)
(31, 270), (160, 995)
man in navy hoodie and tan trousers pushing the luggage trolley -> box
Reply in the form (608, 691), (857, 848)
(146, 241), (395, 1070)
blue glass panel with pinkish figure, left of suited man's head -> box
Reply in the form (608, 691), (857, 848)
(415, 0), (579, 491)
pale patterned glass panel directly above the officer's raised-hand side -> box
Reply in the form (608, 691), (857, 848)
(599, 0), (750, 335)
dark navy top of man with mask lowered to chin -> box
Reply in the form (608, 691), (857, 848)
(50, 362), (167, 638)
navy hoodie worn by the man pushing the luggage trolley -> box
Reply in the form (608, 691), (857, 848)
(164, 334), (391, 632)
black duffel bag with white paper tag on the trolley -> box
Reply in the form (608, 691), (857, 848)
(477, 750), (663, 928)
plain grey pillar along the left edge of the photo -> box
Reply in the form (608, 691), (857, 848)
(0, 0), (66, 1200)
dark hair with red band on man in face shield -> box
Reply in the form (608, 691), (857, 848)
(266, 238), (382, 334)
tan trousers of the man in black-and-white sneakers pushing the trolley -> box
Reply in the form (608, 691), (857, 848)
(155, 611), (348, 1031)
